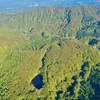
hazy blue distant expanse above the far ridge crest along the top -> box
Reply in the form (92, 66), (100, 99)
(0, 0), (100, 13)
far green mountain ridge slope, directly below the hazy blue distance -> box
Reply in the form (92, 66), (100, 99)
(0, 6), (100, 48)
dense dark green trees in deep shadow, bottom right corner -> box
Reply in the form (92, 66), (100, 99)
(79, 64), (100, 100)
